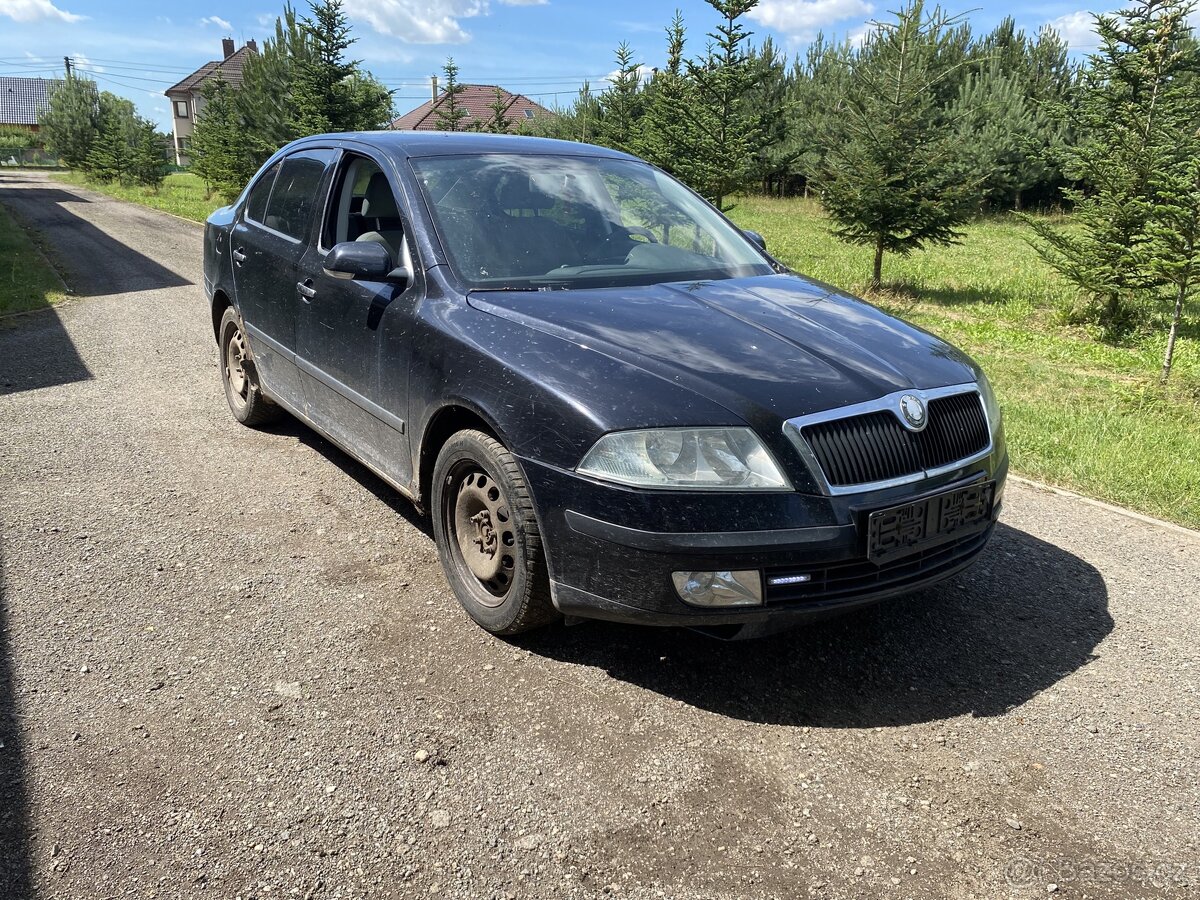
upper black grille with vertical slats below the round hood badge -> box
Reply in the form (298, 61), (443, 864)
(802, 391), (989, 487)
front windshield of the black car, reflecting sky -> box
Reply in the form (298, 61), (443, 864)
(413, 154), (772, 290)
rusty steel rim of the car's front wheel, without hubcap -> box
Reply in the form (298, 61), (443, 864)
(451, 469), (516, 607)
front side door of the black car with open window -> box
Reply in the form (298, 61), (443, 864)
(296, 152), (422, 486)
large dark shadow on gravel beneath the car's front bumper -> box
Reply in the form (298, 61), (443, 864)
(520, 524), (1112, 728)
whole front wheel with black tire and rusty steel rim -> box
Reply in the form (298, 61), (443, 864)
(431, 431), (558, 635)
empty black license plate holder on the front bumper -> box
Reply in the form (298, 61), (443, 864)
(866, 481), (996, 563)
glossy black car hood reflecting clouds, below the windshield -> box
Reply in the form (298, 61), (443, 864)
(469, 275), (977, 424)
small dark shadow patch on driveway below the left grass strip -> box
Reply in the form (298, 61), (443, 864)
(0, 310), (91, 396)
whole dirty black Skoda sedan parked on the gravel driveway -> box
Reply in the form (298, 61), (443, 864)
(204, 132), (1008, 637)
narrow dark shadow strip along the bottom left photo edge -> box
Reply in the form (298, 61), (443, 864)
(0, 542), (34, 900)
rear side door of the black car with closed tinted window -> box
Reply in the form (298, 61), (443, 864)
(230, 149), (337, 412)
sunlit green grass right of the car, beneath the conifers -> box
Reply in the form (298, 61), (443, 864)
(732, 198), (1200, 528)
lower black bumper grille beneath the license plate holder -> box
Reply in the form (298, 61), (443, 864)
(766, 523), (991, 604)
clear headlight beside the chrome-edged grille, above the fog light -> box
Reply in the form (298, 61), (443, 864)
(576, 428), (792, 491)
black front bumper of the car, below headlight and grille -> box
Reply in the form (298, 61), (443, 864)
(522, 445), (1008, 630)
